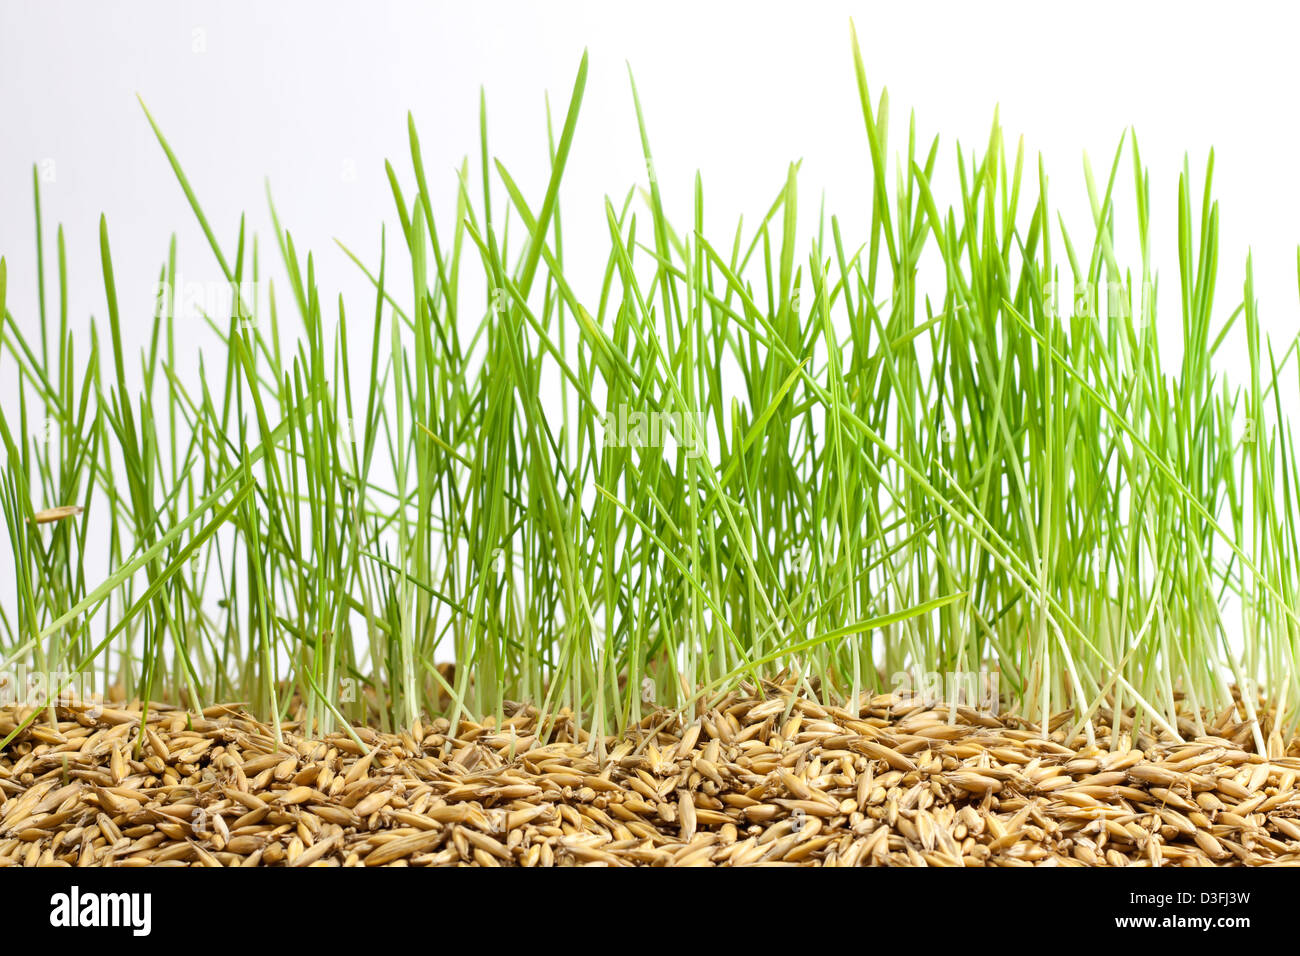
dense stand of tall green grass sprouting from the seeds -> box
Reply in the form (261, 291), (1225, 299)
(0, 24), (1300, 748)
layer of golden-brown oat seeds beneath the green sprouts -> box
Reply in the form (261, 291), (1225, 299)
(0, 692), (1300, 866)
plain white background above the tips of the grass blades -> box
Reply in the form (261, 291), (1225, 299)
(0, 0), (1300, 374)
